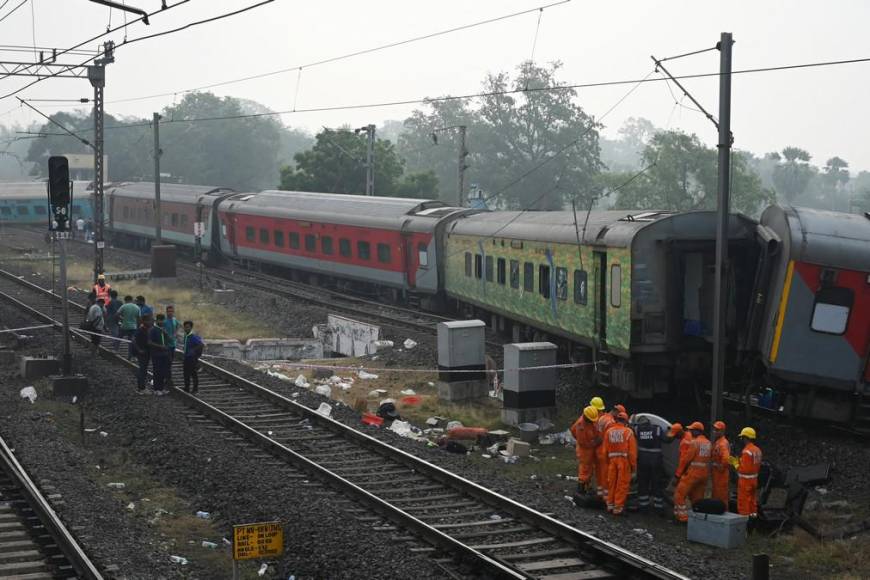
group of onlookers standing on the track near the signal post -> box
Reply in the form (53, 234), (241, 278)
(82, 274), (205, 395)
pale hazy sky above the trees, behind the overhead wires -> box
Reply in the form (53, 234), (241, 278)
(0, 0), (870, 172)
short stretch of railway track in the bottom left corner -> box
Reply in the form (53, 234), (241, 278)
(0, 430), (102, 580)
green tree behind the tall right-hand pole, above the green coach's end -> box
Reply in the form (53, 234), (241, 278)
(605, 131), (774, 215)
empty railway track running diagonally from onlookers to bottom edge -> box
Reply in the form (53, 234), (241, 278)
(0, 271), (685, 580)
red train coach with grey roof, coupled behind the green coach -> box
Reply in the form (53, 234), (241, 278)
(218, 191), (468, 297)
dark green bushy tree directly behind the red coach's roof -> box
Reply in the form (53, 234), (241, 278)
(280, 128), (438, 198)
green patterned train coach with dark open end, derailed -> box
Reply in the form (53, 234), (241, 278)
(444, 211), (759, 397)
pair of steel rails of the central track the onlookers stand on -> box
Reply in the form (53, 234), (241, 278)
(0, 270), (687, 580)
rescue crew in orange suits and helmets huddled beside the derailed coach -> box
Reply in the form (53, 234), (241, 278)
(571, 397), (761, 523)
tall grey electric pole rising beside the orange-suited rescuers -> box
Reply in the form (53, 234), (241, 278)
(710, 32), (734, 424)
